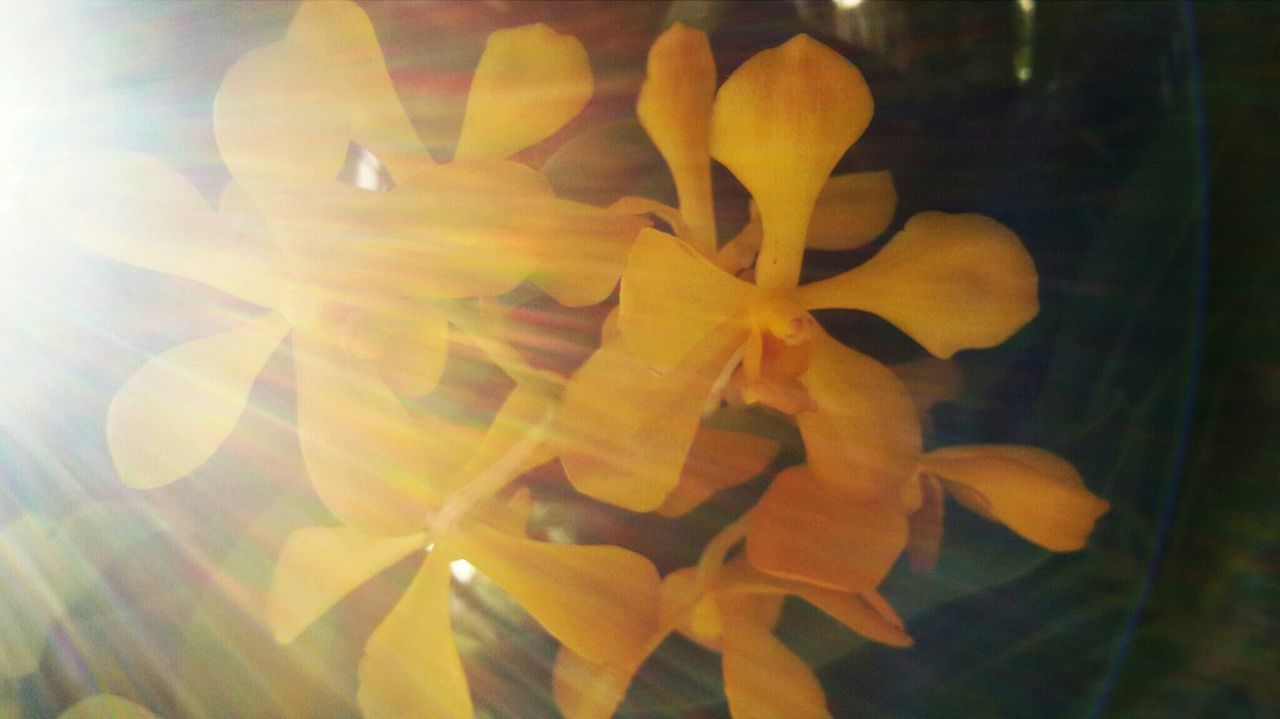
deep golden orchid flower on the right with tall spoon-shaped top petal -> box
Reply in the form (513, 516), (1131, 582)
(561, 26), (1038, 591)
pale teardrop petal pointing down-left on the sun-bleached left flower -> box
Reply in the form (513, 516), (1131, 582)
(106, 312), (289, 489)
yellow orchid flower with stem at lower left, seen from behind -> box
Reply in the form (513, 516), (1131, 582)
(264, 388), (659, 719)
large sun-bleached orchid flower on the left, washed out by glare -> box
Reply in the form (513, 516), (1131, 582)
(40, 1), (643, 532)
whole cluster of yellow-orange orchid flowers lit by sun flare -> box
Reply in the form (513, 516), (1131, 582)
(27, 1), (1107, 719)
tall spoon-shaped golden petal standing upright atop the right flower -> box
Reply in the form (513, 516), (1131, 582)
(710, 35), (872, 289)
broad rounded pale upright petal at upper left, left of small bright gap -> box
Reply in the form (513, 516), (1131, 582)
(214, 42), (351, 188)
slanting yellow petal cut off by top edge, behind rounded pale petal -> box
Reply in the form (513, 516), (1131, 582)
(288, 0), (431, 182)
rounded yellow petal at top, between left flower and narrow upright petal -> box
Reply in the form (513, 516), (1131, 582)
(453, 23), (594, 160)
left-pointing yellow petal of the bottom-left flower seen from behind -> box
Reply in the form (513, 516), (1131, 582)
(265, 527), (426, 644)
